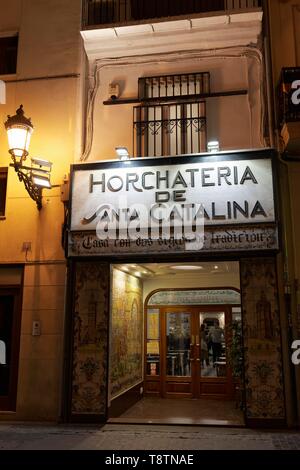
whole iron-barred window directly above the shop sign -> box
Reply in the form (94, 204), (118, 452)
(133, 72), (210, 157)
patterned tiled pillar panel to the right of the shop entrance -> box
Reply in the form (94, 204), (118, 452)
(241, 258), (285, 420)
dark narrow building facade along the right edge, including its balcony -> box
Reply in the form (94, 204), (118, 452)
(266, 1), (300, 424)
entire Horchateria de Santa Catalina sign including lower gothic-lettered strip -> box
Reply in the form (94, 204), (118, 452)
(69, 153), (278, 256)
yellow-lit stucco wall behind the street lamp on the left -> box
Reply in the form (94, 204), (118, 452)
(0, 0), (84, 421)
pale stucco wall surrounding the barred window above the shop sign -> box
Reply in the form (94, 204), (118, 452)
(88, 52), (264, 160)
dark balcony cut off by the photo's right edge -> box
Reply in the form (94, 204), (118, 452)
(278, 67), (300, 156)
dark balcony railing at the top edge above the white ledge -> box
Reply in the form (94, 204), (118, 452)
(83, 0), (262, 28)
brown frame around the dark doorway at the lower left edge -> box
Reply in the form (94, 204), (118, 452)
(0, 286), (22, 411)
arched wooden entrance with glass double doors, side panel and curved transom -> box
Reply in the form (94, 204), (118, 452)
(145, 288), (243, 400)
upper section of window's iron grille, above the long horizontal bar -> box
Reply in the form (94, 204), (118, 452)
(139, 72), (210, 101)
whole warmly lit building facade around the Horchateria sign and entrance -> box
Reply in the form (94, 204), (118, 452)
(0, 0), (299, 426)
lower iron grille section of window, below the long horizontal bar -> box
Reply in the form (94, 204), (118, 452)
(133, 101), (206, 157)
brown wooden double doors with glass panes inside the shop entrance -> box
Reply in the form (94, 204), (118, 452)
(161, 307), (233, 398)
